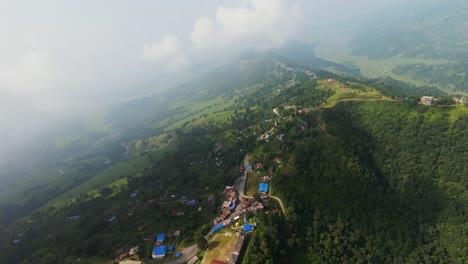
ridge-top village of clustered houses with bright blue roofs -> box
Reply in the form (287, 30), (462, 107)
(108, 140), (284, 264)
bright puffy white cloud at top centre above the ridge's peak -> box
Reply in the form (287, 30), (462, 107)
(190, 0), (304, 50)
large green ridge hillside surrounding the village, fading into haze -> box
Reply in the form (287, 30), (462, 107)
(0, 54), (468, 263)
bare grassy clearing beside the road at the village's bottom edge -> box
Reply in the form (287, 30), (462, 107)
(202, 231), (238, 264)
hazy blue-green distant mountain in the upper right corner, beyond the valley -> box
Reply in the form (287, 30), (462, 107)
(350, 0), (468, 60)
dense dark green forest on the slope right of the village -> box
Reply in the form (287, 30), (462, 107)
(274, 102), (468, 263)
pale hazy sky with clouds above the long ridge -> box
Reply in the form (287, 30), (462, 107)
(0, 0), (420, 171)
